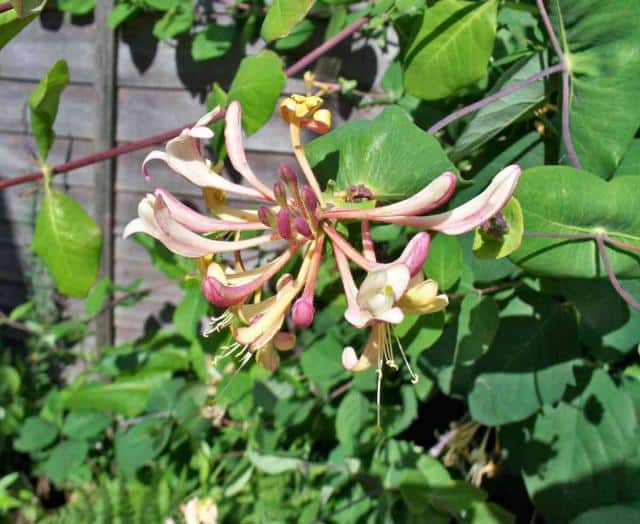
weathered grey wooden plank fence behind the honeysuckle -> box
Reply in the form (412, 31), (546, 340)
(0, 8), (389, 343)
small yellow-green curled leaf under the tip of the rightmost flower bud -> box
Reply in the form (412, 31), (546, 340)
(473, 197), (524, 259)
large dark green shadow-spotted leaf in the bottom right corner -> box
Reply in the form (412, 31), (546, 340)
(501, 368), (640, 522)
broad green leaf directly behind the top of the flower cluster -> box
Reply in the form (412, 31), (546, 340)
(305, 106), (456, 201)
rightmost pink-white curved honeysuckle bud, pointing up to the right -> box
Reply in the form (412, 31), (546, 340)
(376, 165), (521, 235)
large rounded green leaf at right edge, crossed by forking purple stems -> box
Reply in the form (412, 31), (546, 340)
(511, 166), (640, 278)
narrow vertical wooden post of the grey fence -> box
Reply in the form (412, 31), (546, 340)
(93, 0), (117, 348)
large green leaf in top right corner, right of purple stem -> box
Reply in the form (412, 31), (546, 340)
(549, 0), (640, 178)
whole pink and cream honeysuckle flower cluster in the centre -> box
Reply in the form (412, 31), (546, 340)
(124, 95), (520, 422)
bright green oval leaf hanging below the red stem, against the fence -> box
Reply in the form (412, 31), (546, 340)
(31, 190), (102, 297)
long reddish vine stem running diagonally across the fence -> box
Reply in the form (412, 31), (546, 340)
(0, 14), (369, 190)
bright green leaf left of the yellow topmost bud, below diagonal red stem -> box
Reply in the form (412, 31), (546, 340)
(227, 51), (287, 135)
